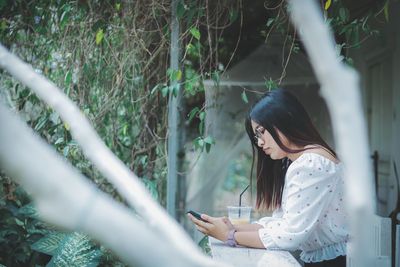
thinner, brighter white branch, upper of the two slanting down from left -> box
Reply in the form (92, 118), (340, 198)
(0, 45), (225, 266)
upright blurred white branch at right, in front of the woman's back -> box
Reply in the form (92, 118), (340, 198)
(288, 0), (376, 266)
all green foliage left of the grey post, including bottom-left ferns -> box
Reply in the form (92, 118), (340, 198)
(0, 0), (173, 266)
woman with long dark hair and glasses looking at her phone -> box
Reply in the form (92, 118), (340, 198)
(188, 89), (348, 266)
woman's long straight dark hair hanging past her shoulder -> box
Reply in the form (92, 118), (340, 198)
(245, 89), (336, 209)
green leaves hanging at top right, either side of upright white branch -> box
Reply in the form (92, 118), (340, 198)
(261, 0), (384, 85)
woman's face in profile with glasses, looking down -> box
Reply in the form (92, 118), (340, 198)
(251, 120), (288, 160)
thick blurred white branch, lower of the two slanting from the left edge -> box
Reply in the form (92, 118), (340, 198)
(0, 104), (216, 267)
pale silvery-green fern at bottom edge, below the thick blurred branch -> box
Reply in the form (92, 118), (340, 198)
(47, 232), (102, 267)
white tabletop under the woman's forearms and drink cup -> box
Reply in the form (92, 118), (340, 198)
(208, 237), (301, 267)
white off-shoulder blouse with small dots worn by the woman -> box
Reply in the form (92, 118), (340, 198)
(256, 152), (349, 262)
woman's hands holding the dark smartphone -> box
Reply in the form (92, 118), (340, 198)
(188, 214), (234, 242)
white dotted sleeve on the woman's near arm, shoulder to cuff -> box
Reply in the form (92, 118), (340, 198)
(259, 154), (340, 250)
